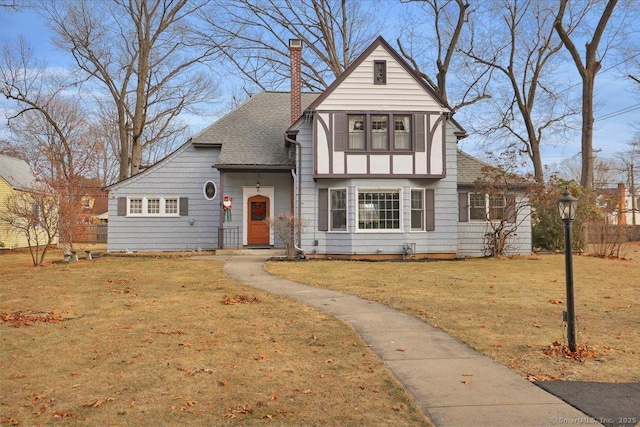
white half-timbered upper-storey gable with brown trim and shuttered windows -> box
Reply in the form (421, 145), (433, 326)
(309, 38), (450, 182)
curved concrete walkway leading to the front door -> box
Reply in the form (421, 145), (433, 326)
(219, 255), (599, 426)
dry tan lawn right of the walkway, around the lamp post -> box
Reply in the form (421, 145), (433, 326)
(267, 243), (640, 382)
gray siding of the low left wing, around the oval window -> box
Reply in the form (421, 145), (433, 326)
(107, 143), (221, 252)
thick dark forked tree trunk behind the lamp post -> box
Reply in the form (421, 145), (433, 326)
(554, 0), (618, 188)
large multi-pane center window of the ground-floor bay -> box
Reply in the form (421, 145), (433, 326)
(358, 190), (400, 230)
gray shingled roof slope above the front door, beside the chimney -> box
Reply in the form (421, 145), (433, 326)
(192, 92), (318, 169)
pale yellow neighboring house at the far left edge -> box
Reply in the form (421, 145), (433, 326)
(0, 154), (57, 249)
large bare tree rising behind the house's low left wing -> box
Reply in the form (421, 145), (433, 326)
(41, 0), (216, 179)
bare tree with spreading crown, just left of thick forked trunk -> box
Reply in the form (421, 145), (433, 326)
(464, 0), (576, 183)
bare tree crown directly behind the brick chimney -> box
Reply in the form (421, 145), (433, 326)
(201, 0), (383, 91)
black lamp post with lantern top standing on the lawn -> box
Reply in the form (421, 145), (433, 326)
(558, 189), (578, 351)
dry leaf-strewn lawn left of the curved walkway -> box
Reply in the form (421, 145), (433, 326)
(0, 253), (430, 426)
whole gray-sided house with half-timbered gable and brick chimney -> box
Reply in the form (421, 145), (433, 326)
(108, 37), (531, 258)
